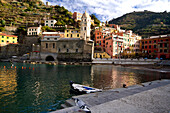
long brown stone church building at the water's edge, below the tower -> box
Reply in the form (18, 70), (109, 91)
(41, 39), (94, 62)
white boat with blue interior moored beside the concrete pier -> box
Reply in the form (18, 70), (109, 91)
(70, 81), (102, 94)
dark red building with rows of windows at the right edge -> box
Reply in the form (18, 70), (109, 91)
(140, 34), (170, 59)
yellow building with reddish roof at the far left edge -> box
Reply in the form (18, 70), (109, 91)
(0, 33), (18, 46)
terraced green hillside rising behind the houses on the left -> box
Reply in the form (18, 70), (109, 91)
(0, 0), (75, 32)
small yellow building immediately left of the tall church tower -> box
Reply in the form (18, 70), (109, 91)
(64, 29), (80, 38)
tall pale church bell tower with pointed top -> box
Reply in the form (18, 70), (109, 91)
(80, 11), (91, 40)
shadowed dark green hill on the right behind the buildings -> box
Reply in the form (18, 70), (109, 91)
(109, 11), (170, 38)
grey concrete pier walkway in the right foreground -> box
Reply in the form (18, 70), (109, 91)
(53, 80), (170, 113)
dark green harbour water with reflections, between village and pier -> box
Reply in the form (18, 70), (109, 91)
(0, 62), (170, 113)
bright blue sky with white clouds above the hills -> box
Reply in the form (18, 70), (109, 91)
(42, 0), (170, 22)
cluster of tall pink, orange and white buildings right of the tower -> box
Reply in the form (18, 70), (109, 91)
(95, 24), (141, 58)
